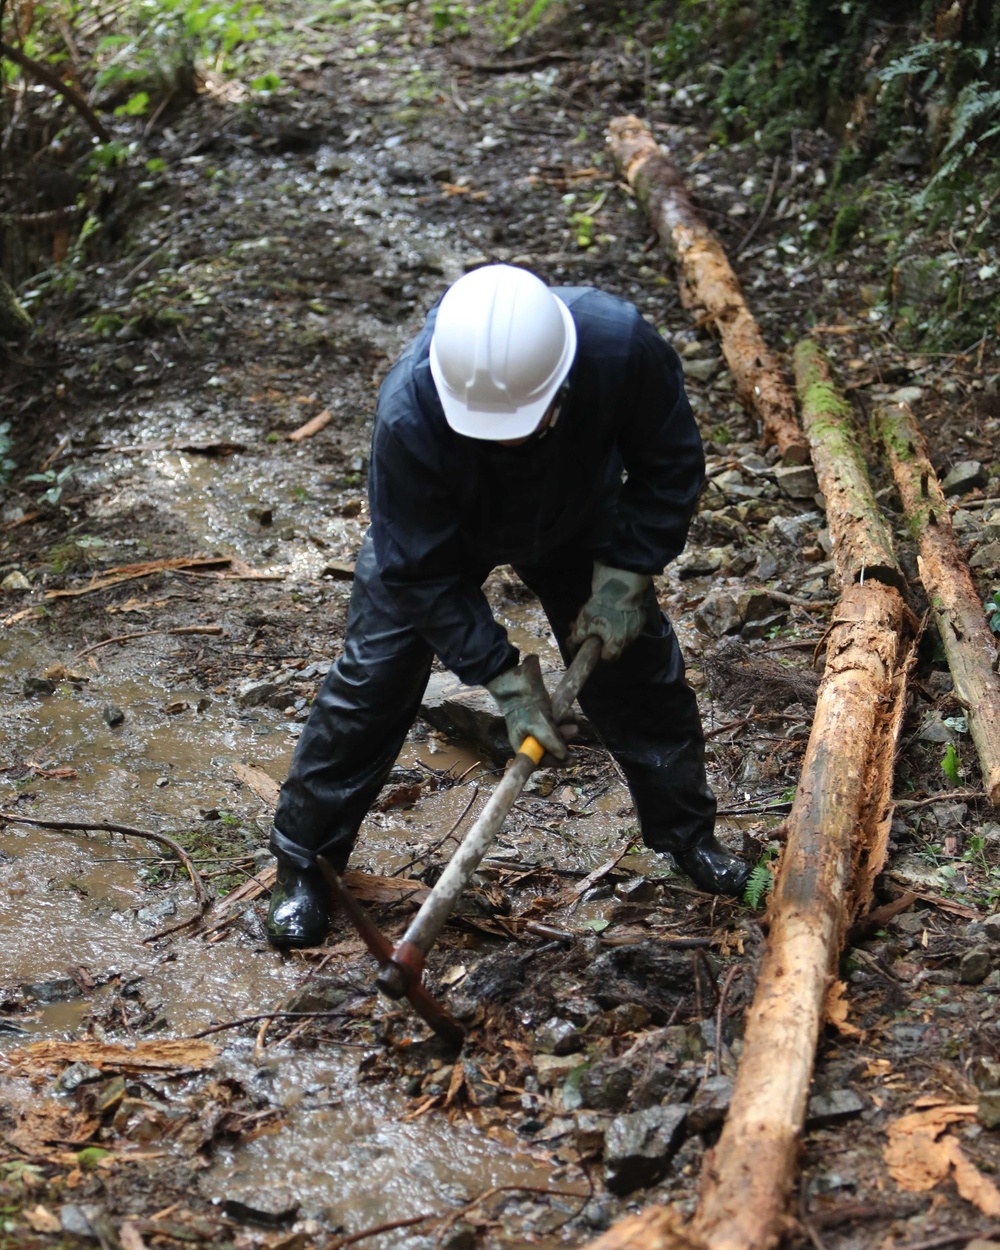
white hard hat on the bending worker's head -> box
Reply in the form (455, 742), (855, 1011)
(430, 265), (576, 440)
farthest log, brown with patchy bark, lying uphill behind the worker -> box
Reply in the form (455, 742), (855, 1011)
(608, 116), (809, 465)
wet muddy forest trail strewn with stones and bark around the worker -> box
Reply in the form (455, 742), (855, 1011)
(0, 6), (1000, 1250)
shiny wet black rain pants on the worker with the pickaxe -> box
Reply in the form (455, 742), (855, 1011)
(271, 536), (715, 871)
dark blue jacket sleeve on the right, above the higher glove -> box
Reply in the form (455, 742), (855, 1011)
(608, 319), (705, 574)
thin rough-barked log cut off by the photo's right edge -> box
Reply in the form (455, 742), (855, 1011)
(874, 404), (1000, 808)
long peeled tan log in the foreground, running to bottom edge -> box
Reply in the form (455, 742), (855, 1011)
(693, 581), (906, 1250)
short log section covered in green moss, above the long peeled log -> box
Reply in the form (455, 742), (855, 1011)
(794, 339), (906, 590)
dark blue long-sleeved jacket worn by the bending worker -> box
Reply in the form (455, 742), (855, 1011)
(369, 286), (705, 685)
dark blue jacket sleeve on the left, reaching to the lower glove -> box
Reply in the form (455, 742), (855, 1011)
(369, 423), (519, 685)
